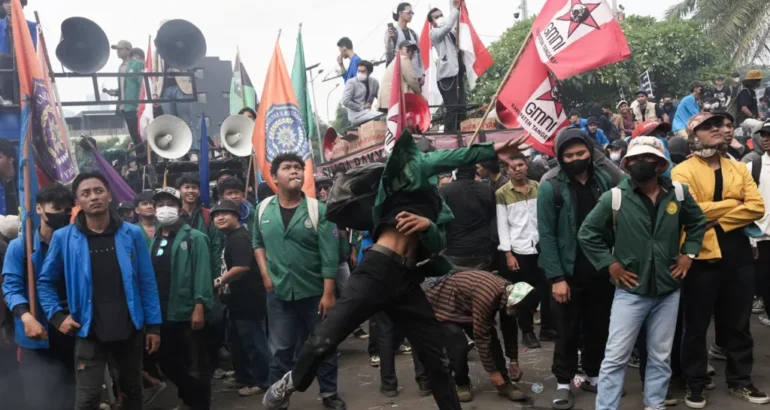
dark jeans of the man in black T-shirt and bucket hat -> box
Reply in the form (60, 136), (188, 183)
(227, 319), (270, 391)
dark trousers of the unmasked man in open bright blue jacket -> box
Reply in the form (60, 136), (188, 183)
(75, 332), (144, 410)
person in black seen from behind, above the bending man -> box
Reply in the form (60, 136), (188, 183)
(439, 165), (495, 270)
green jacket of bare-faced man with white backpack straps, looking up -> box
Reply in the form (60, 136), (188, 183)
(252, 198), (339, 301)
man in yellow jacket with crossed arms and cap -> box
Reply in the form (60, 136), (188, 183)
(672, 113), (770, 408)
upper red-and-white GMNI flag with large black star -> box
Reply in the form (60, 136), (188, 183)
(532, 0), (631, 80)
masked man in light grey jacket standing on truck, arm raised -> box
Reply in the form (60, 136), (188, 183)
(428, 0), (468, 132)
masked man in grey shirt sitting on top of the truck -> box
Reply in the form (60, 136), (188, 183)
(342, 61), (380, 126)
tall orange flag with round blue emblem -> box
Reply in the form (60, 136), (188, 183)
(252, 41), (315, 198)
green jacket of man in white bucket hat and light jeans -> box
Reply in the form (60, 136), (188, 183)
(578, 178), (706, 296)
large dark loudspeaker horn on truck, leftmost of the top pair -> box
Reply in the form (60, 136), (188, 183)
(56, 17), (110, 74)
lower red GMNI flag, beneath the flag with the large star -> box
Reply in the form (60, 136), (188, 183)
(496, 39), (568, 144)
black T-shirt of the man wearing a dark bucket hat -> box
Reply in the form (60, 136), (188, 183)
(222, 227), (267, 320)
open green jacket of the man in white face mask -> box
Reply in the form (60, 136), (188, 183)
(150, 224), (214, 322)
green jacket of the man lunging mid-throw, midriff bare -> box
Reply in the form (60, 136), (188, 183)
(372, 132), (497, 276)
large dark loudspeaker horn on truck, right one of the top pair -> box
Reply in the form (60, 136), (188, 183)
(155, 19), (206, 70)
